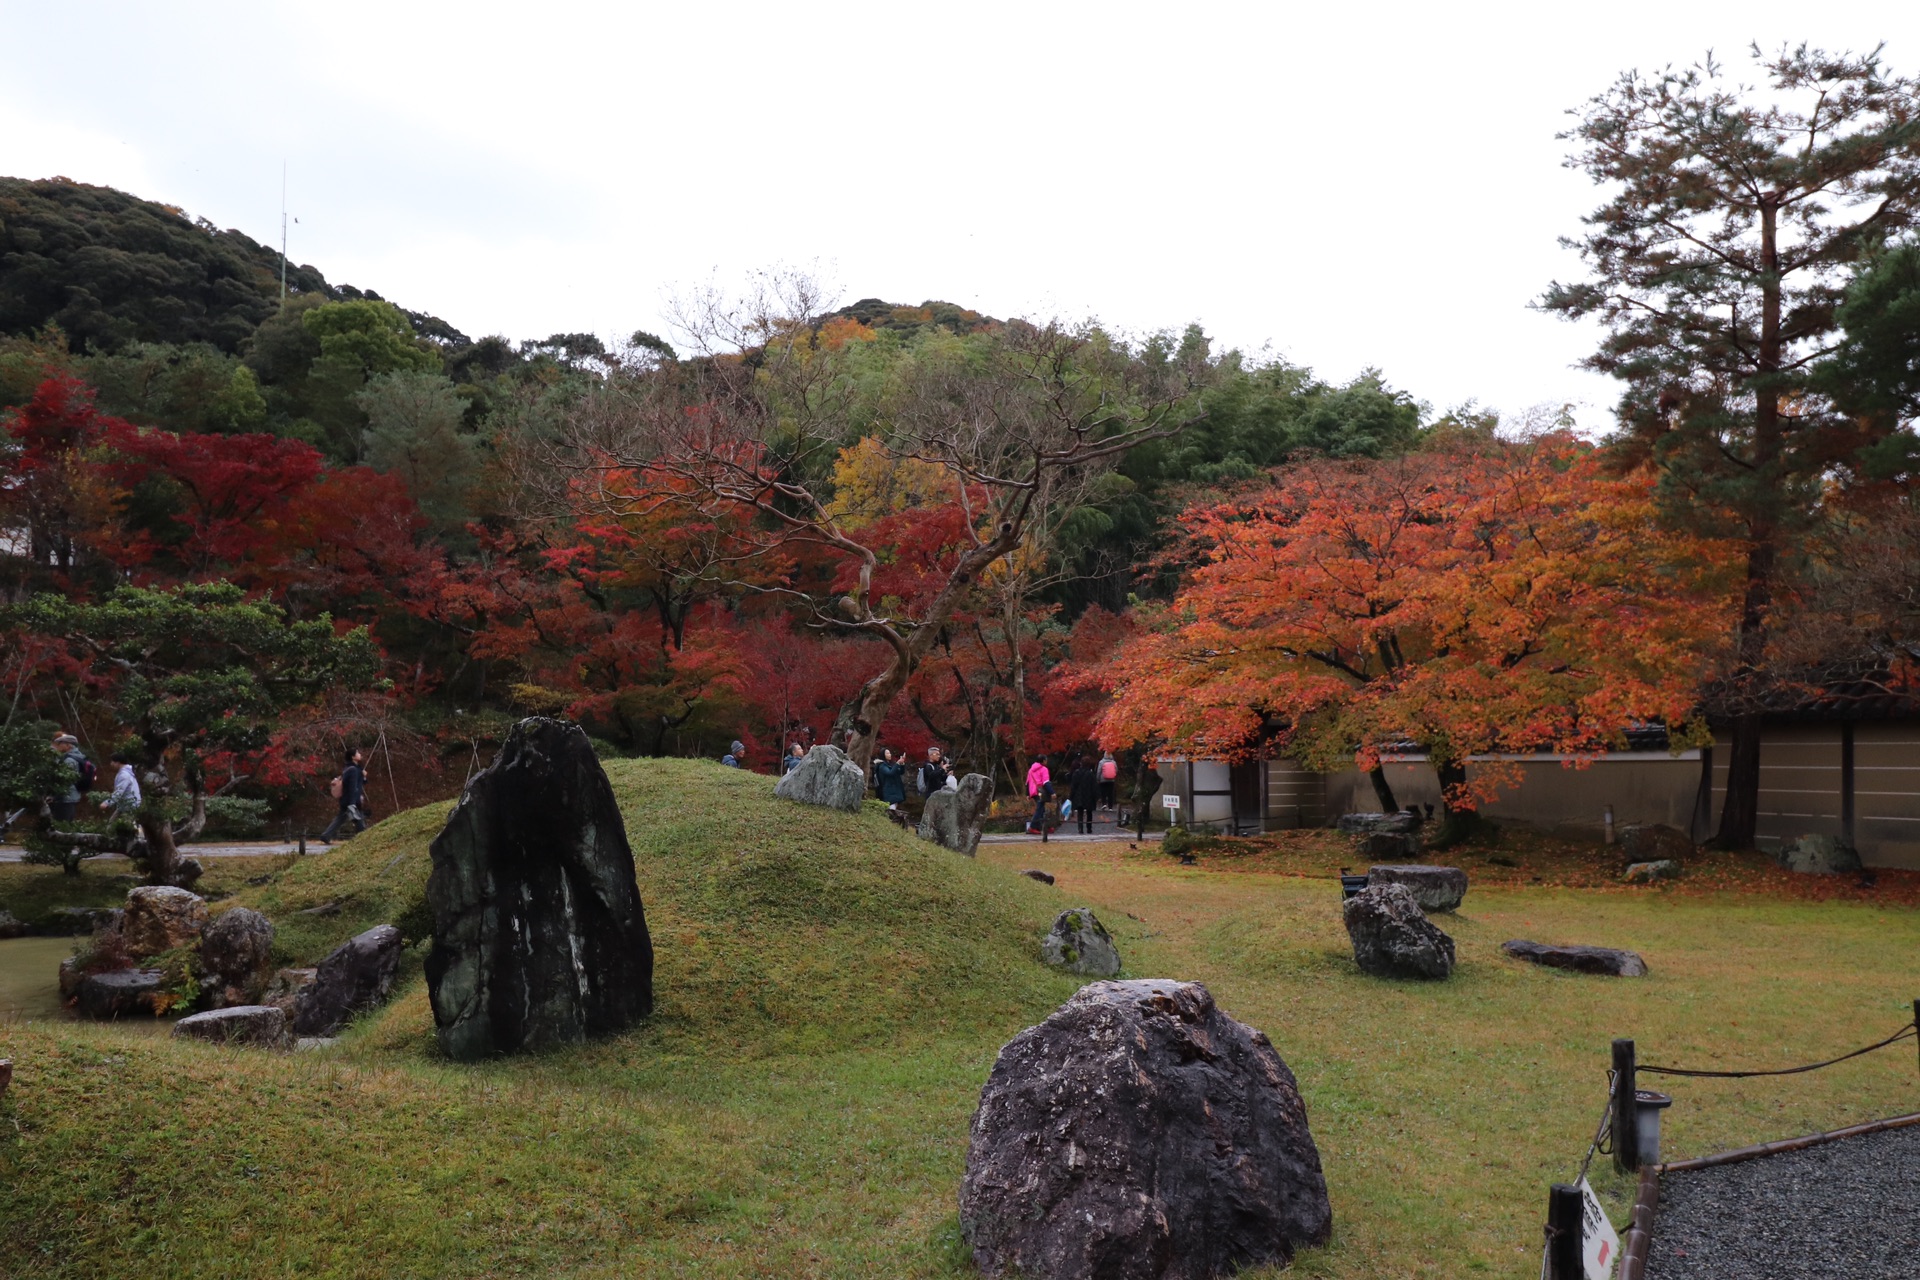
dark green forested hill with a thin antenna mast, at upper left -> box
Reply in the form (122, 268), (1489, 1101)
(0, 177), (465, 353)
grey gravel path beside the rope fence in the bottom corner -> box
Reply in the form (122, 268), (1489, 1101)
(1647, 1125), (1920, 1280)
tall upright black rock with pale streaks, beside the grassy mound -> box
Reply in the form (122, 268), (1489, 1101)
(426, 716), (653, 1059)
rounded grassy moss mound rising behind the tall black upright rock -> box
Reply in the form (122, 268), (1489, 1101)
(232, 760), (1071, 1055)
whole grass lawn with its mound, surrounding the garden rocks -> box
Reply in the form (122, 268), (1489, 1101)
(0, 762), (1920, 1280)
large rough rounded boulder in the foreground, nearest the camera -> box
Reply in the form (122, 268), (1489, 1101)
(960, 979), (1332, 1280)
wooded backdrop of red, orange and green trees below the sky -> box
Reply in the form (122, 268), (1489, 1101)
(0, 47), (1920, 859)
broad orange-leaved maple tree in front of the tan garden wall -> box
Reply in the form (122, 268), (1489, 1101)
(1098, 434), (1738, 814)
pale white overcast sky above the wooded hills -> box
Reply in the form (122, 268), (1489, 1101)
(0, 0), (1920, 426)
